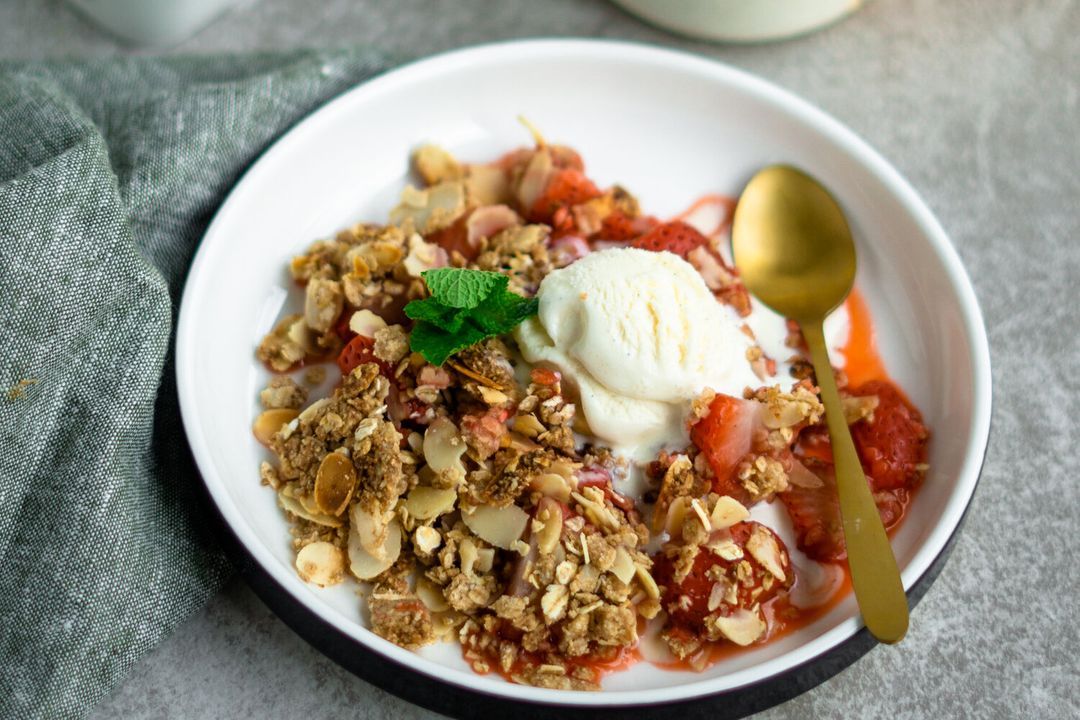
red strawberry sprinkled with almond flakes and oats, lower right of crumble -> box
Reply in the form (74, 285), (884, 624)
(652, 520), (795, 631)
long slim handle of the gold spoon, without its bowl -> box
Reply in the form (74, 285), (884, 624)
(800, 321), (907, 643)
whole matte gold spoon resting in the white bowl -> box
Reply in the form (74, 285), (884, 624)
(731, 165), (907, 642)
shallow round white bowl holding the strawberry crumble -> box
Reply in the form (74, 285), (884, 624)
(177, 40), (990, 708)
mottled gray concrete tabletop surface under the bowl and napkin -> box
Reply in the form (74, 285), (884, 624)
(0, 0), (1080, 720)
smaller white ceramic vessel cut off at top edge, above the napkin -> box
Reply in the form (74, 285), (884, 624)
(69, 0), (245, 45)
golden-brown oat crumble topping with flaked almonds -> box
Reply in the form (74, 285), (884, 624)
(254, 136), (926, 690)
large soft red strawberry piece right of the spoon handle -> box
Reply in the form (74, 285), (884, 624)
(851, 380), (930, 491)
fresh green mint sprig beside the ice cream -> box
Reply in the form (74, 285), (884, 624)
(405, 268), (540, 365)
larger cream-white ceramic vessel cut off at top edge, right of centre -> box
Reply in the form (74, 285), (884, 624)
(613, 0), (864, 42)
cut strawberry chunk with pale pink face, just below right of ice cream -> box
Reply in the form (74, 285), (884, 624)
(690, 393), (758, 503)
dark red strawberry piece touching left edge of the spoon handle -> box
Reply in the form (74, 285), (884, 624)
(777, 459), (848, 562)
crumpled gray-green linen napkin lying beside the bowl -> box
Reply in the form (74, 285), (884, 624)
(0, 50), (388, 718)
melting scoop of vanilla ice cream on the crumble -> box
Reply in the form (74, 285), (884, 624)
(516, 248), (759, 457)
